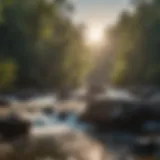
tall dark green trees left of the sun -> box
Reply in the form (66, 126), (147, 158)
(0, 0), (88, 89)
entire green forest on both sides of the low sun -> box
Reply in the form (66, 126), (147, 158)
(0, 0), (160, 91)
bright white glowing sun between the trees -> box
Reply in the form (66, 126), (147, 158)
(86, 26), (104, 44)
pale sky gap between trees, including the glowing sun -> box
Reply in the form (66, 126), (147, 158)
(70, 0), (131, 45)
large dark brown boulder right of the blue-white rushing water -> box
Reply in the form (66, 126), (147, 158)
(80, 99), (160, 132)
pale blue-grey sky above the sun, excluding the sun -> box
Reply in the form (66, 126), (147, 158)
(72, 0), (130, 28)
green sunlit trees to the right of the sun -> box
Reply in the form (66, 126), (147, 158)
(111, 0), (160, 85)
